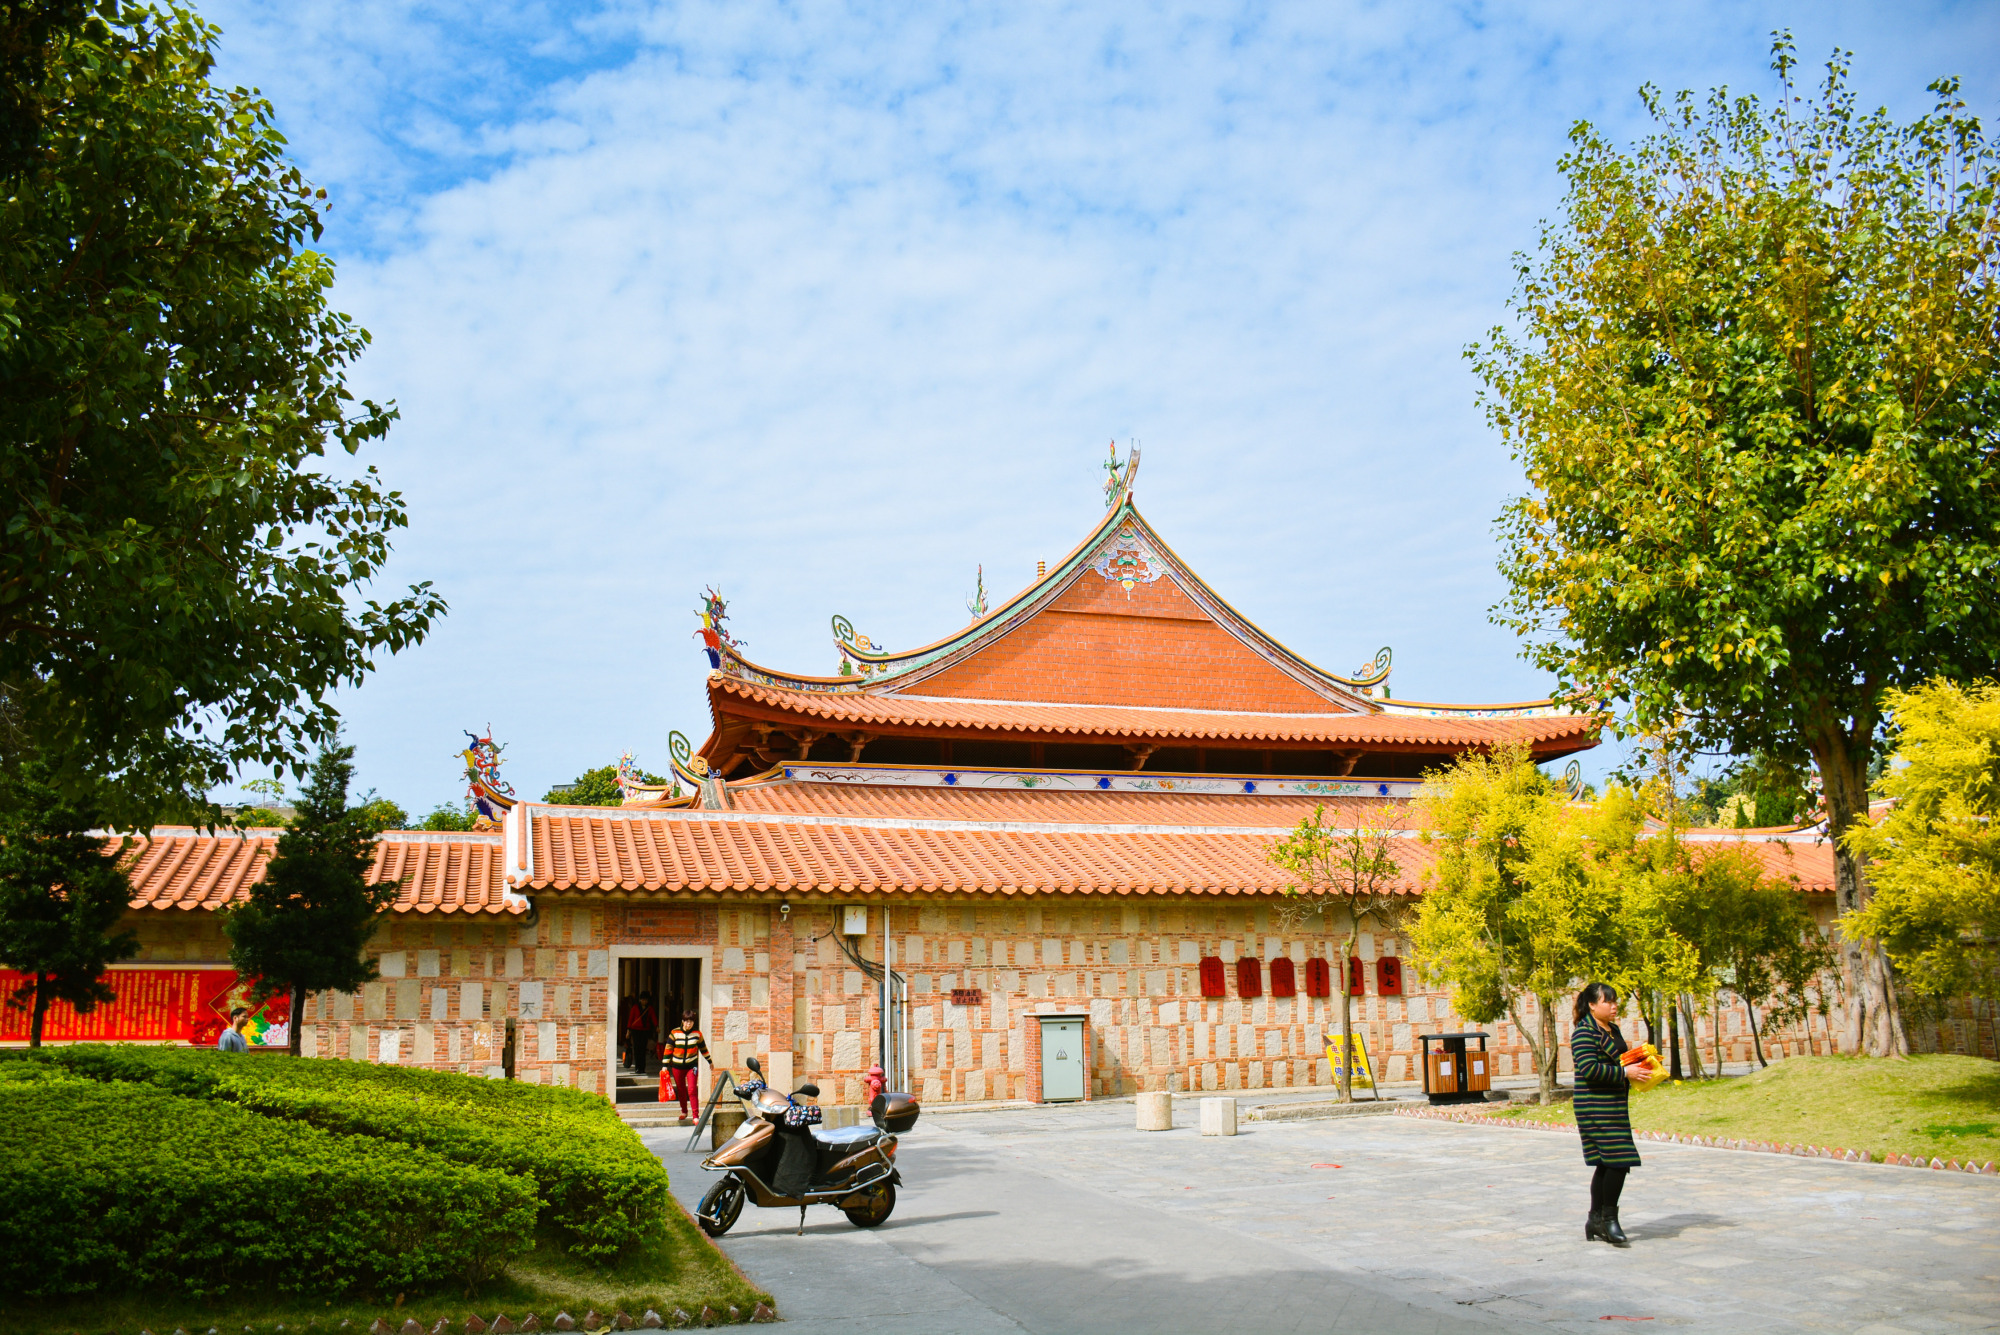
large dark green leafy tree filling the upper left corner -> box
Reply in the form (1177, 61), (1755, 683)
(0, 0), (444, 823)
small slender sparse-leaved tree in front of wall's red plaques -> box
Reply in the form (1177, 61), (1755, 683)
(1270, 803), (1402, 1103)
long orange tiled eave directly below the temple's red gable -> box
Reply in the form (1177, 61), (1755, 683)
(708, 673), (1598, 753)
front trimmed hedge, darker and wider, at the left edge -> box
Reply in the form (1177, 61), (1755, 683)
(0, 1087), (534, 1299)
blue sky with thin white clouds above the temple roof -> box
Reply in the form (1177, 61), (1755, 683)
(202, 0), (2000, 811)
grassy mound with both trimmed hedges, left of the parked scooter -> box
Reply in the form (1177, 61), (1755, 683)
(0, 1045), (770, 1335)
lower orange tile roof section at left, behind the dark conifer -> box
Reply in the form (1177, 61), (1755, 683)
(112, 829), (528, 913)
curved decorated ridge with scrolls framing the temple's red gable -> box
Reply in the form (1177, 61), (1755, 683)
(712, 496), (1400, 713)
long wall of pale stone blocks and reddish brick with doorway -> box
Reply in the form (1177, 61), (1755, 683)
(97, 895), (1856, 1103)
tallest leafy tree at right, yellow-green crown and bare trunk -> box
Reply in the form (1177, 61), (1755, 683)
(1468, 36), (2000, 1055)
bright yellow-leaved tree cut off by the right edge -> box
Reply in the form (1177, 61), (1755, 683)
(1844, 681), (2000, 997)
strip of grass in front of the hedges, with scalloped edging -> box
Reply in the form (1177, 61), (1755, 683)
(0, 1205), (770, 1335)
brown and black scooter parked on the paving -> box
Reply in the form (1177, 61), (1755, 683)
(694, 1057), (920, 1237)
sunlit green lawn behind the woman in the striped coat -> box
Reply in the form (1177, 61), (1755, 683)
(1496, 1055), (2000, 1163)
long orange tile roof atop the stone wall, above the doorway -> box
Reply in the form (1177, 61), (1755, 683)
(524, 807), (1832, 895)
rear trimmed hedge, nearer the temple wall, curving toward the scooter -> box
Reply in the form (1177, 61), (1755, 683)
(21, 1043), (672, 1261)
